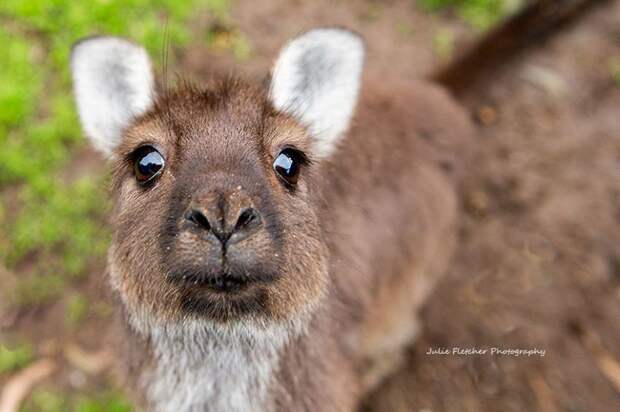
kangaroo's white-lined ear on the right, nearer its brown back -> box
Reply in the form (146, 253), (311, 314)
(270, 28), (364, 157)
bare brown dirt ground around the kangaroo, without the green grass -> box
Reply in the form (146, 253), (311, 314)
(4, 0), (620, 412)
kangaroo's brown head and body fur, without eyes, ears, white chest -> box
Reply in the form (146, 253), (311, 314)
(110, 71), (472, 411)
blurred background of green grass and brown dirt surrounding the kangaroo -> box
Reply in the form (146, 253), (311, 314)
(0, 0), (620, 412)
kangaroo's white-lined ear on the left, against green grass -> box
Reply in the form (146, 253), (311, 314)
(71, 37), (154, 155)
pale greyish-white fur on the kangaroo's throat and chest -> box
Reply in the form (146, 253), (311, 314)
(135, 323), (300, 412)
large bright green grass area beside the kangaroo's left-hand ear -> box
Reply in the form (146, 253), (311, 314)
(0, 0), (230, 304)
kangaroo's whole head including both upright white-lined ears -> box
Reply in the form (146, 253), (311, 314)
(72, 29), (363, 330)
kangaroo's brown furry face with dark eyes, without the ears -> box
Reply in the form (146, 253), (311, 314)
(111, 83), (326, 321)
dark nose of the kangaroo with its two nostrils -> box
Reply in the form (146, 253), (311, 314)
(185, 195), (262, 246)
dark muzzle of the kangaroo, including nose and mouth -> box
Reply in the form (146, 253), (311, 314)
(165, 182), (278, 300)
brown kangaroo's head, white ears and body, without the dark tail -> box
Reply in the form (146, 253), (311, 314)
(71, 0), (604, 412)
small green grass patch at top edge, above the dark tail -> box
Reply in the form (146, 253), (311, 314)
(417, 0), (523, 30)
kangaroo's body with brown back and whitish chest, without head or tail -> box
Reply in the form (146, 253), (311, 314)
(109, 82), (472, 411)
